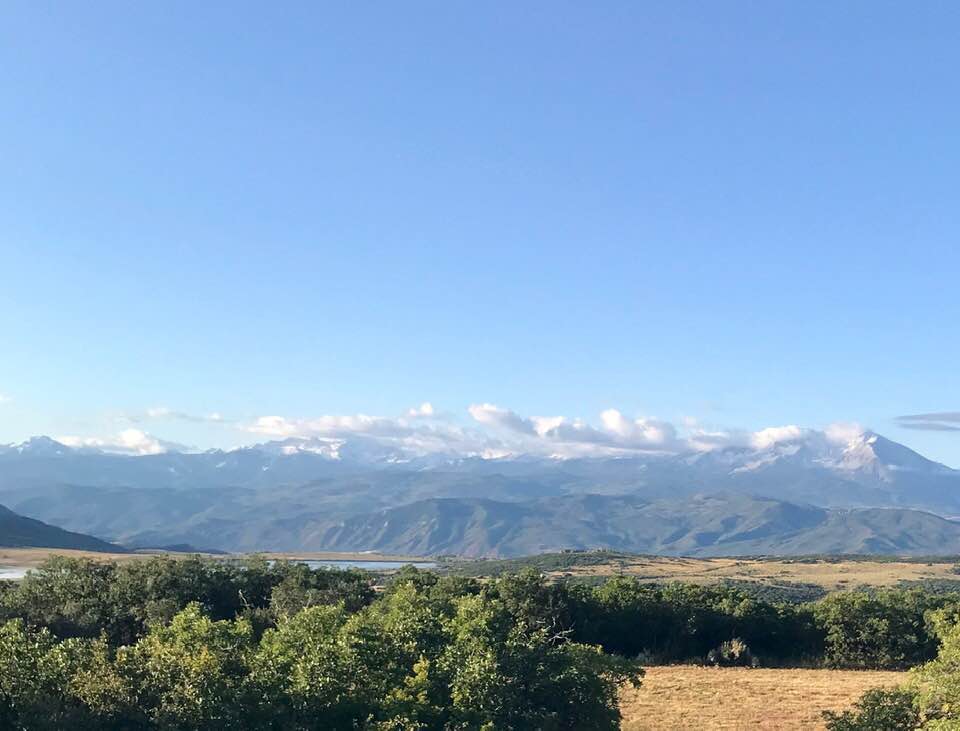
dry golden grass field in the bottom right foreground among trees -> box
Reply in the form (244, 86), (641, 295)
(621, 665), (907, 731)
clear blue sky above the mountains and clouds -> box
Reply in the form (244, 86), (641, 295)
(0, 0), (960, 467)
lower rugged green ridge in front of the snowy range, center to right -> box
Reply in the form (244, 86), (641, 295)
(309, 495), (960, 556)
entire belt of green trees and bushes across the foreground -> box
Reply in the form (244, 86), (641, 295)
(0, 558), (960, 731)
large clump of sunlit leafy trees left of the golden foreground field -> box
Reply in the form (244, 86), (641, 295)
(0, 559), (640, 731)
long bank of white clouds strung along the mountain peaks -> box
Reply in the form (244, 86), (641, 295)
(31, 402), (884, 460)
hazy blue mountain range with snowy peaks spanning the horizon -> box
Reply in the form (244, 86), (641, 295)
(0, 427), (960, 556)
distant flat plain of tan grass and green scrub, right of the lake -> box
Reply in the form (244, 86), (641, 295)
(456, 551), (960, 591)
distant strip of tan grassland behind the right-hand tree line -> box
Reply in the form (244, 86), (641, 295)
(551, 556), (960, 591)
